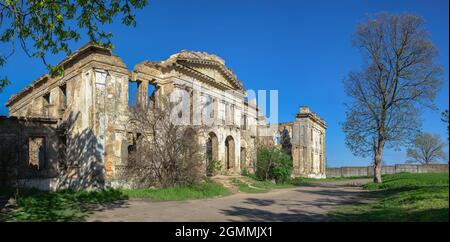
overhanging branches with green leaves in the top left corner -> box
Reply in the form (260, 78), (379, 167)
(0, 0), (148, 92)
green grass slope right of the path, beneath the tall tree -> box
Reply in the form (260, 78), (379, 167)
(330, 173), (449, 222)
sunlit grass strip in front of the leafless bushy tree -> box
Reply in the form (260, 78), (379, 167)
(121, 182), (230, 201)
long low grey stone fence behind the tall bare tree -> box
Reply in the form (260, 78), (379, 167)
(326, 164), (448, 177)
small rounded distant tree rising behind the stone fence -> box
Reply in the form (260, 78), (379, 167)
(406, 133), (446, 165)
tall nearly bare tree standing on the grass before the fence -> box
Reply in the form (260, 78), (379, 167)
(343, 13), (442, 183)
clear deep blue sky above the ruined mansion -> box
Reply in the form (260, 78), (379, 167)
(0, 0), (449, 166)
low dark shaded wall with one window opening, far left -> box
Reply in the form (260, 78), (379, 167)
(0, 116), (60, 186)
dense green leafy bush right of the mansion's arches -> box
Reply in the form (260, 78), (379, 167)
(256, 147), (292, 183)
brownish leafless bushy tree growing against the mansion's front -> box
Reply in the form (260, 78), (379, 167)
(123, 98), (206, 187)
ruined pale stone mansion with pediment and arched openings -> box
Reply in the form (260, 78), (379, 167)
(0, 44), (326, 190)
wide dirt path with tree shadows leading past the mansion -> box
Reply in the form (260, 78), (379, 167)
(88, 180), (368, 221)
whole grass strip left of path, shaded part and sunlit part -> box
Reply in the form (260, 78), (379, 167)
(0, 182), (230, 222)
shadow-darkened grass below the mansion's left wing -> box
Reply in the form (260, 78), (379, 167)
(0, 189), (123, 221)
